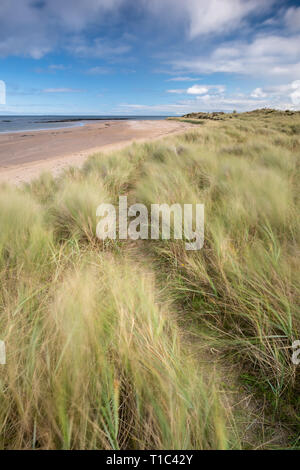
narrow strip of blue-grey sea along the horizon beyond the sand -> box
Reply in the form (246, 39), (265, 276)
(0, 115), (168, 134)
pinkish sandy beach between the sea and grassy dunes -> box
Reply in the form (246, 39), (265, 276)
(0, 120), (191, 184)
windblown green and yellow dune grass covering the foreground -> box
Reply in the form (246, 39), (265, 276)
(0, 110), (300, 449)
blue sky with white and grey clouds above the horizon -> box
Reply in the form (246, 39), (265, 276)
(0, 0), (300, 115)
